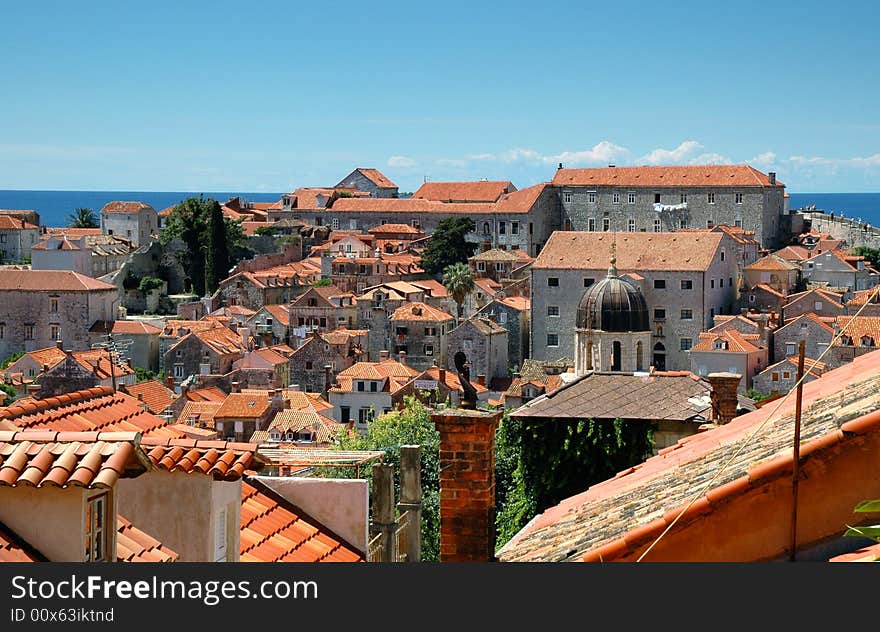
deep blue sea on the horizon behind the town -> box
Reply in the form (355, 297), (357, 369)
(0, 191), (880, 226)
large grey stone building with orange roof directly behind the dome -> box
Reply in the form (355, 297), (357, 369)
(530, 231), (739, 370)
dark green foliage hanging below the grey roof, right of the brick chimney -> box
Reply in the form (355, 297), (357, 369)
(495, 416), (653, 548)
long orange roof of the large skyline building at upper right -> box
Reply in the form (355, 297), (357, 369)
(553, 165), (785, 187)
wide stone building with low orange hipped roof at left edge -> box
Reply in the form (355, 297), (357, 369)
(0, 270), (119, 358)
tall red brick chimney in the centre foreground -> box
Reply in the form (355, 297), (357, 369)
(431, 410), (503, 562)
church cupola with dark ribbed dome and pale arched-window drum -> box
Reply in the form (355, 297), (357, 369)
(574, 255), (651, 375)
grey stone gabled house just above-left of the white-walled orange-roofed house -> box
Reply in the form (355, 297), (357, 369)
(289, 331), (363, 393)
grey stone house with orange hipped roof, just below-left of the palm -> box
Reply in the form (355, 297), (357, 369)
(390, 303), (454, 371)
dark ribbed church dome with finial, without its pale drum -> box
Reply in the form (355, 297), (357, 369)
(577, 259), (650, 332)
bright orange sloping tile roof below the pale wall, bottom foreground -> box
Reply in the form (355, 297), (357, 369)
(240, 478), (364, 562)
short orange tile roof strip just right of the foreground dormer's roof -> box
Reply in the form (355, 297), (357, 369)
(141, 437), (259, 481)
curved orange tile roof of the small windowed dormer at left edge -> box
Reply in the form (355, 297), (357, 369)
(0, 430), (147, 489)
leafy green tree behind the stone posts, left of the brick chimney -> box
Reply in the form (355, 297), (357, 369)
(334, 396), (440, 562)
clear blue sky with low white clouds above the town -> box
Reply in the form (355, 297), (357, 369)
(0, 0), (880, 192)
